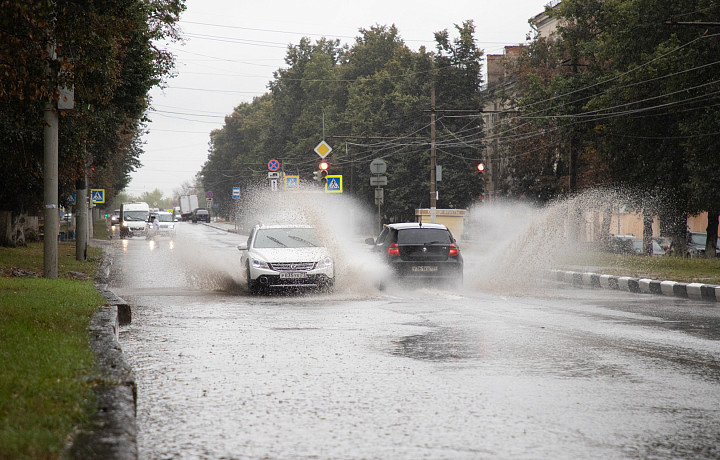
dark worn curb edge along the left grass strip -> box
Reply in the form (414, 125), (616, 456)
(68, 243), (138, 460)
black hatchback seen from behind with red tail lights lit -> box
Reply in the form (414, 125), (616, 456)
(365, 222), (463, 284)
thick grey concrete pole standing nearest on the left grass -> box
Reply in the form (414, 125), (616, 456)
(43, 44), (60, 279)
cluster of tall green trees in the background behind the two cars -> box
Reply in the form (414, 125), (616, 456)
(200, 22), (482, 220)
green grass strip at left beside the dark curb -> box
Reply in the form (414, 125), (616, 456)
(0, 225), (105, 459)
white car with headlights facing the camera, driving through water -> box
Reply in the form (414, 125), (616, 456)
(238, 225), (335, 294)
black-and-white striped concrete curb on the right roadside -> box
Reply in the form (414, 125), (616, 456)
(545, 270), (720, 302)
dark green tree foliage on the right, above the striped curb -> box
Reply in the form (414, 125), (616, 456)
(508, 0), (720, 221)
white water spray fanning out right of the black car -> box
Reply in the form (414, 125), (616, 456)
(465, 189), (644, 295)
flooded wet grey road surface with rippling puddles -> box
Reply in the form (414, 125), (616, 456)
(110, 223), (720, 459)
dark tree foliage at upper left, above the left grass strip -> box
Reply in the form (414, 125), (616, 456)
(0, 0), (185, 216)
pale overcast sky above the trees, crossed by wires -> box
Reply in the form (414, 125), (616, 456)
(126, 0), (548, 197)
